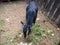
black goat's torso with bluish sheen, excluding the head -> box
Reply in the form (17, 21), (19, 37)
(26, 1), (38, 25)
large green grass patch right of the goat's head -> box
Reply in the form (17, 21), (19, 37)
(30, 23), (55, 45)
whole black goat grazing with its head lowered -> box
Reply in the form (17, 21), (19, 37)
(21, 1), (38, 38)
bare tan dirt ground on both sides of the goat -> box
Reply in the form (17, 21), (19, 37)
(0, 2), (60, 45)
